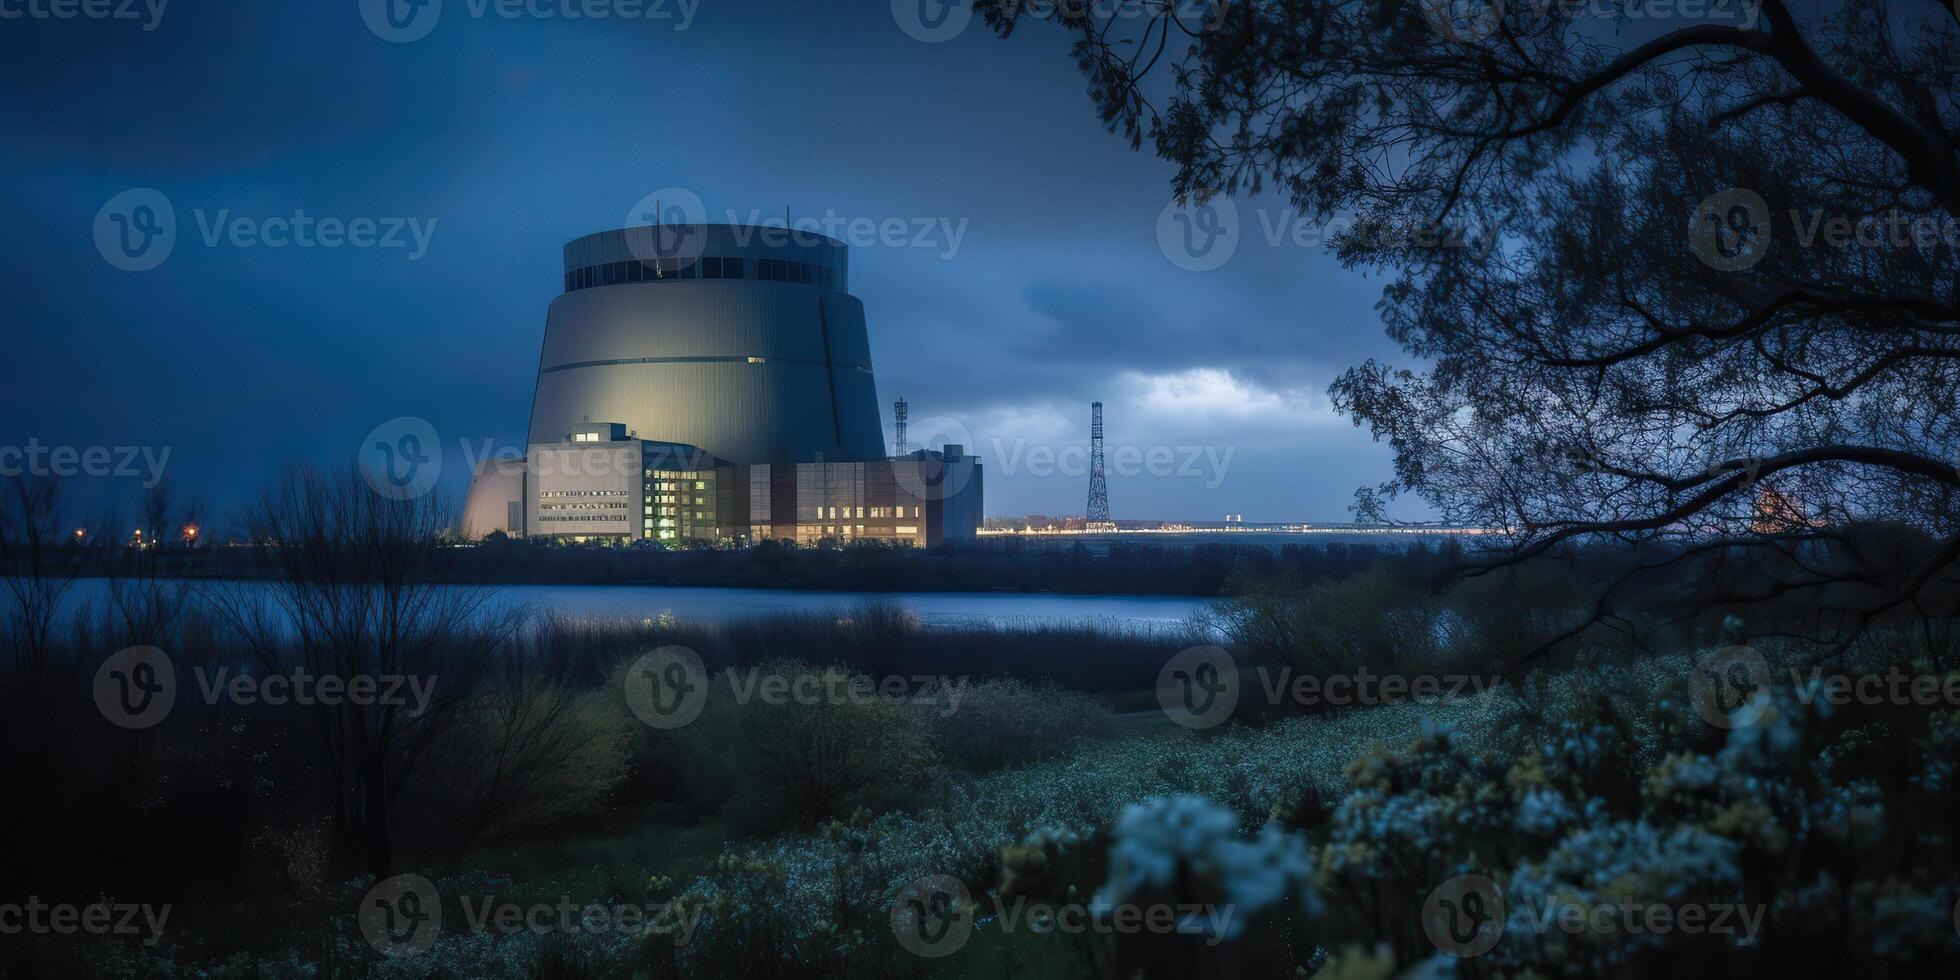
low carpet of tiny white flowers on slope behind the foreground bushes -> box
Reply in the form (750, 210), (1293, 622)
(646, 692), (1515, 976)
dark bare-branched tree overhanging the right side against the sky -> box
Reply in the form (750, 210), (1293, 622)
(980, 0), (1960, 650)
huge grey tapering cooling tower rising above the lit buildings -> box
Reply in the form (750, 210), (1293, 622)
(527, 225), (884, 463)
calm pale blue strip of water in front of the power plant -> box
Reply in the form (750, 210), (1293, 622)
(57, 578), (1209, 629)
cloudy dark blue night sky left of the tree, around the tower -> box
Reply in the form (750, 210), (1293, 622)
(0, 0), (1421, 521)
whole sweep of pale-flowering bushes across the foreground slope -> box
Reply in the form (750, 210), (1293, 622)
(69, 635), (1960, 980)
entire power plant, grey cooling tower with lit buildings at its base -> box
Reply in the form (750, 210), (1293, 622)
(461, 223), (982, 547)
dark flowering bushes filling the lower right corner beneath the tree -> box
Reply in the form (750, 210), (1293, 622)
(1301, 657), (1960, 976)
